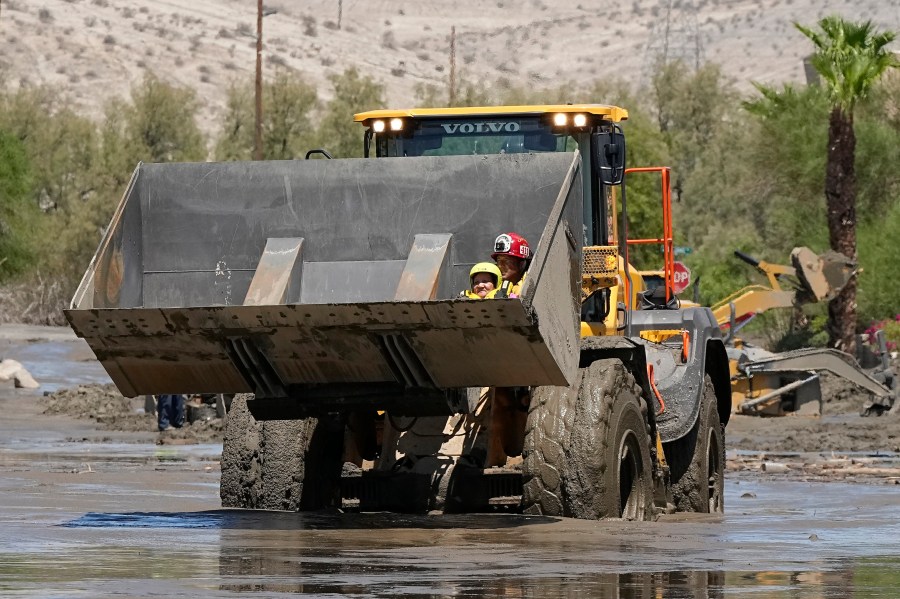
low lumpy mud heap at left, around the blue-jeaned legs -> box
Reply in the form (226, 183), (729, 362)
(42, 384), (225, 445)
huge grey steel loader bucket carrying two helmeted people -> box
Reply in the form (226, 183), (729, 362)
(66, 153), (583, 403)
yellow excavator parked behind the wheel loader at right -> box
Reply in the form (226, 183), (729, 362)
(712, 247), (895, 416)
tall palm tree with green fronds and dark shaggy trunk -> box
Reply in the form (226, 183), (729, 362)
(794, 16), (900, 354)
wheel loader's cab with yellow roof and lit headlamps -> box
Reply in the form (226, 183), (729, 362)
(354, 104), (640, 332)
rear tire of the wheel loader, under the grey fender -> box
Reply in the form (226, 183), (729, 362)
(663, 375), (725, 514)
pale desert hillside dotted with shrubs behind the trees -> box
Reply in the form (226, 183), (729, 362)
(0, 0), (900, 131)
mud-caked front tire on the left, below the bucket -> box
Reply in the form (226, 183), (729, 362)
(219, 394), (343, 511)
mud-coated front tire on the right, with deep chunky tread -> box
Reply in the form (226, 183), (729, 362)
(522, 360), (654, 520)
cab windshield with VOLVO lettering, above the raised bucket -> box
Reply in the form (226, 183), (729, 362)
(377, 116), (577, 156)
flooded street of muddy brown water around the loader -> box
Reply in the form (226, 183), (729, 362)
(0, 330), (900, 598)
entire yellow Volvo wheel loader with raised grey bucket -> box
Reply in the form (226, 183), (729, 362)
(66, 104), (731, 520)
